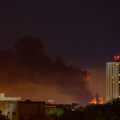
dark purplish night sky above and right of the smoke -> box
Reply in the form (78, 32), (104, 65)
(0, 0), (120, 102)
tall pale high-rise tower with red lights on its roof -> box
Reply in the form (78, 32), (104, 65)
(106, 56), (120, 102)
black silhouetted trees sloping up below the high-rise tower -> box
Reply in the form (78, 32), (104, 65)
(57, 99), (120, 120)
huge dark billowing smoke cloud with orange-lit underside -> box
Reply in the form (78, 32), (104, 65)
(0, 37), (91, 103)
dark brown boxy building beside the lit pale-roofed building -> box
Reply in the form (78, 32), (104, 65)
(18, 101), (45, 120)
